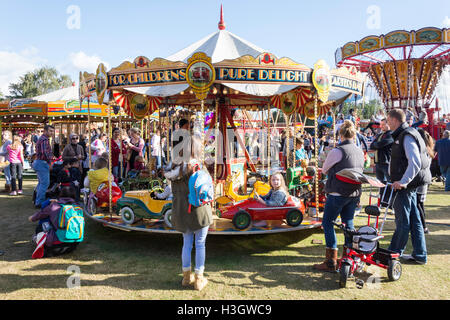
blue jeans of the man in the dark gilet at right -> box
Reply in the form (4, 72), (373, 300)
(389, 189), (427, 262)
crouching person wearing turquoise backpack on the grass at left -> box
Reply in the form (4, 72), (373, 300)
(28, 186), (84, 258)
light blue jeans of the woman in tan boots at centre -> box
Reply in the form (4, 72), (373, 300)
(181, 227), (209, 273)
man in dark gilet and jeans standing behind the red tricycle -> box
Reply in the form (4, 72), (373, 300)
(387, 109), (431, 264)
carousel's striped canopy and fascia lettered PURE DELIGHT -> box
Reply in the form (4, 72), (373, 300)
(80, 7), (363, 119)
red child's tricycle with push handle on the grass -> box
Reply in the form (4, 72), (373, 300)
(333, 183), (402, 288)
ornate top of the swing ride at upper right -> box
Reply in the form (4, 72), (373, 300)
(335, 27), (450, 111)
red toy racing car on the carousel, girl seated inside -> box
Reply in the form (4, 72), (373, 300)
(217, 196), (305, 230)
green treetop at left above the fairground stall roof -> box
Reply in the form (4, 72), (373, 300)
(9, 67), (72, 98)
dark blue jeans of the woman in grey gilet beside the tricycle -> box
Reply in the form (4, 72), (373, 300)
(322, 195), (360, 249)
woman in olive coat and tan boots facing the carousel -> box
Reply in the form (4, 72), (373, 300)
(165, 135), (213, 290)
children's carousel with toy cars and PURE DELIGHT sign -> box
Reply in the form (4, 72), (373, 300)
(80, 8), (363, 235)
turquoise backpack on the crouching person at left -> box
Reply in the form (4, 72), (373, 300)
(56, 204), (84, 242)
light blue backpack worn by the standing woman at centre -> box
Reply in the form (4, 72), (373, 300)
(188, 166), (214, 212)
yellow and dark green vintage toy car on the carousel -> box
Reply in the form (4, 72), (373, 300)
(116, 185), (172, 228)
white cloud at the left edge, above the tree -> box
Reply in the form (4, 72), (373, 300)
(0, 47), (47, 95)
